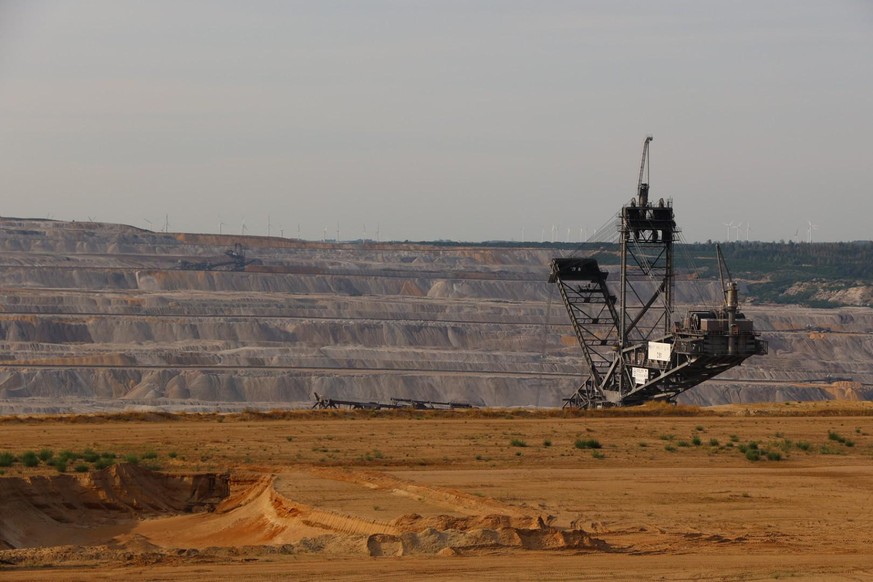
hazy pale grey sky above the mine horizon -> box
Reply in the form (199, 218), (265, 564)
(0, 0), (873, 242)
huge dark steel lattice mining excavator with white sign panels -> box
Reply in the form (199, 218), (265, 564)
(549, 136), (767, 408)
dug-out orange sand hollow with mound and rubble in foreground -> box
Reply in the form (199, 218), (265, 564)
(0, 464), (605, 559)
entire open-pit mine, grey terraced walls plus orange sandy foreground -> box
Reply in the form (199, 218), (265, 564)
(0, 186), (873, 581)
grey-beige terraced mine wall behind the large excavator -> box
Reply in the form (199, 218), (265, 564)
(0, 218), (873, 413)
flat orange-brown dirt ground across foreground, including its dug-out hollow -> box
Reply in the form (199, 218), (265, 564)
(0, 402), (873, 581)
